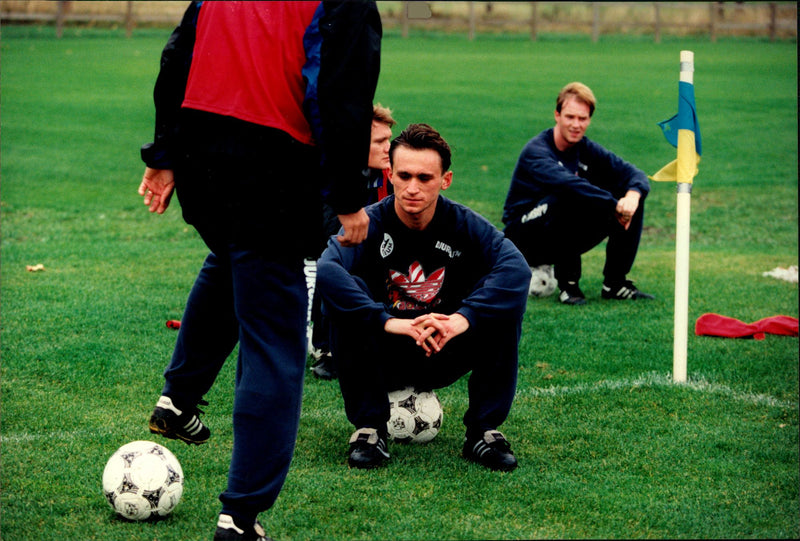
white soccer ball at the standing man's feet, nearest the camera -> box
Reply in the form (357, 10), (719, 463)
(103, 441), (183, 520)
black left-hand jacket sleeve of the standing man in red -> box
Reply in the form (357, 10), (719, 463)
(141, 2), (202, 169)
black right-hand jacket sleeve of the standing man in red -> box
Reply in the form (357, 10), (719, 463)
(310, 1), (382, 214)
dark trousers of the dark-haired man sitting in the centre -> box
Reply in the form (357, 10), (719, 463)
(331, 312), (521, 438)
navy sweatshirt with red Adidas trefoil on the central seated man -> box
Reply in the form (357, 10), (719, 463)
(317, 195), (531, 331)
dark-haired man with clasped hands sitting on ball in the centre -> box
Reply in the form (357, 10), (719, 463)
(317, 124), (530, 471)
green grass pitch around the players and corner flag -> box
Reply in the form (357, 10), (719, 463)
(0, 26), (800, 541)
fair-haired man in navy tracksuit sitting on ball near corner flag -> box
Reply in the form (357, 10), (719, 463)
(503, 82), (653, 305)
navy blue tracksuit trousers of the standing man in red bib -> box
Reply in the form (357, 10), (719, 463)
(163, 247), (308, 524)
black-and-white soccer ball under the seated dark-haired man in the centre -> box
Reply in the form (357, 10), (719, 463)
(387, 387), (442, 443)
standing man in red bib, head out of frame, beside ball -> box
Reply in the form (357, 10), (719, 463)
(139, 2), (381, 540)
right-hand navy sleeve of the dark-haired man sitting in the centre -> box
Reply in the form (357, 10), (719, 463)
(457, 215), (531, 327)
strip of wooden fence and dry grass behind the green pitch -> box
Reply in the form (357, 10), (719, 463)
(0, 0), (797, 42)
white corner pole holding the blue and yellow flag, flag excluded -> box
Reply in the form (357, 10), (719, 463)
(672, 51), (694, 383)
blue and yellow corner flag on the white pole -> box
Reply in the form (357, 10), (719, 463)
(650, 81), (702, 184)
